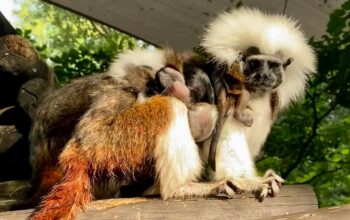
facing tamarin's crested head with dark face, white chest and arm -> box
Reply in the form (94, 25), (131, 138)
(201, 8), (316, 201)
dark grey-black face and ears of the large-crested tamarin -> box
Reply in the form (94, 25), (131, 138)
(242, 47), (292, 91)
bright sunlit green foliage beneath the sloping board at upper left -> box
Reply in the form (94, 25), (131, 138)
(15, 0), (147, 83)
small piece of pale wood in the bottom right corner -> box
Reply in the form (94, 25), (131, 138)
(266, 205), (350, 220)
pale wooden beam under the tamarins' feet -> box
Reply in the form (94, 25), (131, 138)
(0, 185), (317, 220)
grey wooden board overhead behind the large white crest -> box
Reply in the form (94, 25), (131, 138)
(46, 0), (345, 50)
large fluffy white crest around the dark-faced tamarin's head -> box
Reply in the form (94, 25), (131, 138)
(201, 8), (316, 107)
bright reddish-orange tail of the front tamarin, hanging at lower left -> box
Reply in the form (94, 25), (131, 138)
(29, 143), (92, 220)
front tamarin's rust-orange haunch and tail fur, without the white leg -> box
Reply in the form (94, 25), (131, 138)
(30, 94), (172, 220)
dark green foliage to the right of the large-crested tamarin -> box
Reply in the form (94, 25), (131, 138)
(259, 0), (350, 207)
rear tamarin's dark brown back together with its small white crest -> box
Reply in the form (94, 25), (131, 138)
(28, 49), (189, 205)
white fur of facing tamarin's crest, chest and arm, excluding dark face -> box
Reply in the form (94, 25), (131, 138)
(201, 8), (316, 196)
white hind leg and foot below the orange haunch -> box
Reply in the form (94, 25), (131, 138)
(151, 99), (235, 199)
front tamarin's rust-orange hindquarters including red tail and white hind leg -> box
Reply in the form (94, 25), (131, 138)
(30, 96), (235, 219)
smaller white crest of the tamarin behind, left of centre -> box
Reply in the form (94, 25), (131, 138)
(107, 49), (165, 80)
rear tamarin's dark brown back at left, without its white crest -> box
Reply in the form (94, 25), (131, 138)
(27, 74), (136, 205)
